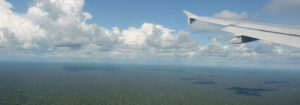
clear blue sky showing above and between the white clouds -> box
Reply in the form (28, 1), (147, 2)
(7, 0), (300, 30)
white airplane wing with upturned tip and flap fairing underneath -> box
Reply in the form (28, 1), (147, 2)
(183, 11), (300, 48)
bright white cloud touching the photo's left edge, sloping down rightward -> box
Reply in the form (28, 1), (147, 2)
(0, 0), (47, 49)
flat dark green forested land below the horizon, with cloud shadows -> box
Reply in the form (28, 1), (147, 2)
(0, 63), (300, 105)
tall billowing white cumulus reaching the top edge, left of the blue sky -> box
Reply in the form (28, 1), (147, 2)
(27, 0), (119, 51)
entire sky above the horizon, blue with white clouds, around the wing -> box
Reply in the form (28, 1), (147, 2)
(0, 0), (300, 68)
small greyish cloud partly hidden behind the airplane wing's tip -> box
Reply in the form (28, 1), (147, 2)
(190, 10), (248, 32)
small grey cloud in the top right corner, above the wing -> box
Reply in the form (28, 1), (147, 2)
(266, 0), (300, 13)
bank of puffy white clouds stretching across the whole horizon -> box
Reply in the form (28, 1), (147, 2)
(0, 0), (300, 68)
